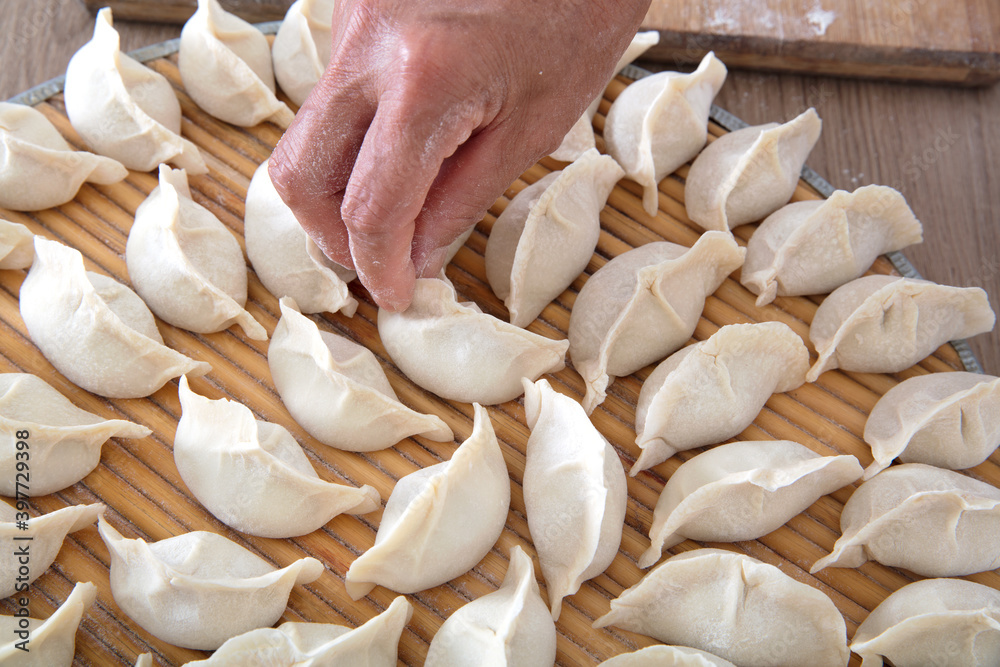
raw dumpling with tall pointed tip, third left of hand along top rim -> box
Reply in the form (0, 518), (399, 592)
(65, 7), (208, 177)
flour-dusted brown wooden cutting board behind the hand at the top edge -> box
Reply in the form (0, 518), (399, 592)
(84, 0), (1000, 85)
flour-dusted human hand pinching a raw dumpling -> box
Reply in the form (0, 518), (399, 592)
(269, 0), (650, 310)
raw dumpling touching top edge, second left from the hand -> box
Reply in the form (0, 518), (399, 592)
(178, 0), (295, 128)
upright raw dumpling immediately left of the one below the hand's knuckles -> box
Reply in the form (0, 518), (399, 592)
(125, 164), (267, 340)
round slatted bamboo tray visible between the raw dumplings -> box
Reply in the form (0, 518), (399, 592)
(0, 31), (1000, 665)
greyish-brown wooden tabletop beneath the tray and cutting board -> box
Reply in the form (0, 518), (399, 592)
(0, 0), (1000, 375)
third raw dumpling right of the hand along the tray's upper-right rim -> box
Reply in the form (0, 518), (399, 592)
(684, 109), (822, 231)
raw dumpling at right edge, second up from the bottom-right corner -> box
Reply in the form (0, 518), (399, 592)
(809, 463), (1000, 577)
